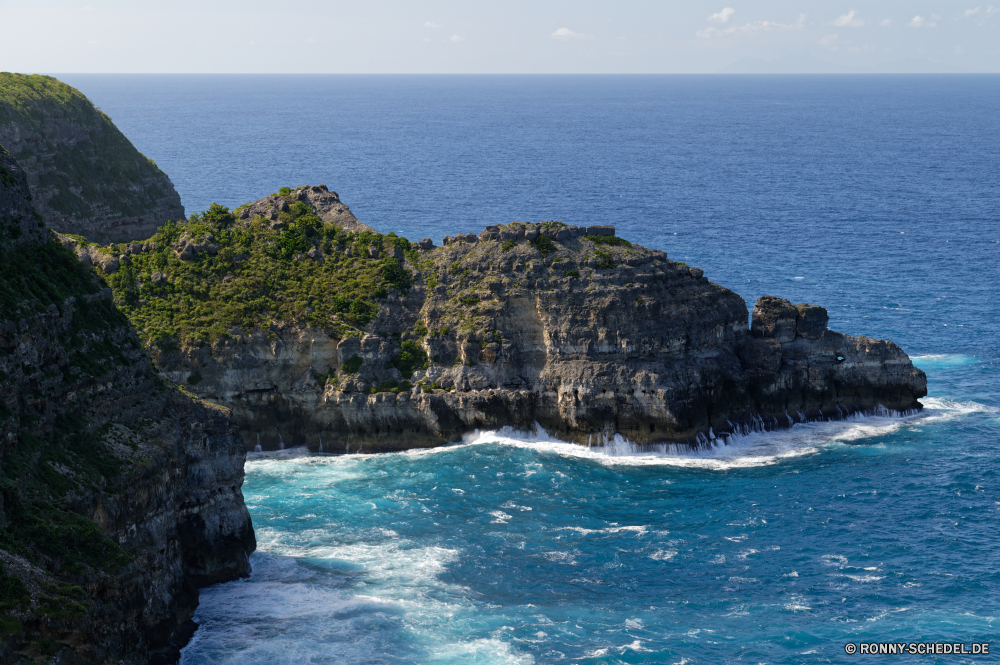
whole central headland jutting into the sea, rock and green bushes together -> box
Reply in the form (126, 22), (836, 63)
(90, 190), (926, 452)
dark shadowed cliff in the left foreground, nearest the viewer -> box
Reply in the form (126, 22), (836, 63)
(0, 150), (255, 664)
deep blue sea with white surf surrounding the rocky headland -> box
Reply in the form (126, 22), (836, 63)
(60, 75), (1000, 665)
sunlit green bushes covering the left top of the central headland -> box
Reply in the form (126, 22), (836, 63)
(100, 198), (412, 350)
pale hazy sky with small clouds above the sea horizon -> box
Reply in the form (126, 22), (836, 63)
(0, 0), (1000, 73)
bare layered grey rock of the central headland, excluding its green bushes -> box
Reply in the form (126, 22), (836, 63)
(139, 210), (926, 452)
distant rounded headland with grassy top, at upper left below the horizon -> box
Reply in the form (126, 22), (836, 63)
(0, 73), (184, 242)
